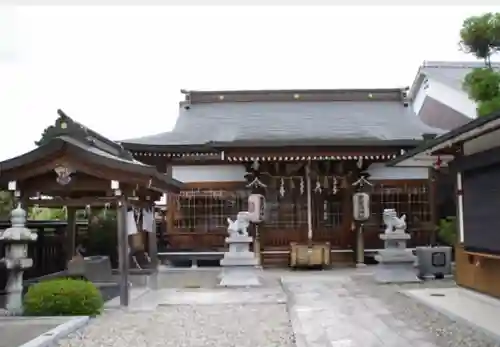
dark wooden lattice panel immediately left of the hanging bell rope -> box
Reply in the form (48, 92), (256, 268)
(266, 179), (307, 229)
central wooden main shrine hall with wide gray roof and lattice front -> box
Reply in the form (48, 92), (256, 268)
(121, 88), (443, 264)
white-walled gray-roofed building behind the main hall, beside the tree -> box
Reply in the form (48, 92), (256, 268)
(409, 61), (500, 130)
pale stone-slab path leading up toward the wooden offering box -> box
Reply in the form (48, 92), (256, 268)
(282, 275), (436, 347)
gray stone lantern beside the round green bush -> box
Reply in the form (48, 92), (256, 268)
(0, 204), (38, 315)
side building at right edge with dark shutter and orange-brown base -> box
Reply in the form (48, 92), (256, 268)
(390, 112), (500, 298)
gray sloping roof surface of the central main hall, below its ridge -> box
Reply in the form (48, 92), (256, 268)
(122, 94), (443, 145)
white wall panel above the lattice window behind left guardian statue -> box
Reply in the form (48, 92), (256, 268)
(172, 165), (246, 183)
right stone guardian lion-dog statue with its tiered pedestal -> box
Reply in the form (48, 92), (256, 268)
(374, 209), (420, 283)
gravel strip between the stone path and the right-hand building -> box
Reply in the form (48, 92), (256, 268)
(350, 276), (500, 347)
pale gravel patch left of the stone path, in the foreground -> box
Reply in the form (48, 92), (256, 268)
(59, 304), (295, 347)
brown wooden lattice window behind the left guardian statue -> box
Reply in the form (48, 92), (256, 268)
(174, 189), (249, 231)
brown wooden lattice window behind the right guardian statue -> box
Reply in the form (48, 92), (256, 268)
(368, 184), (431, 232)
